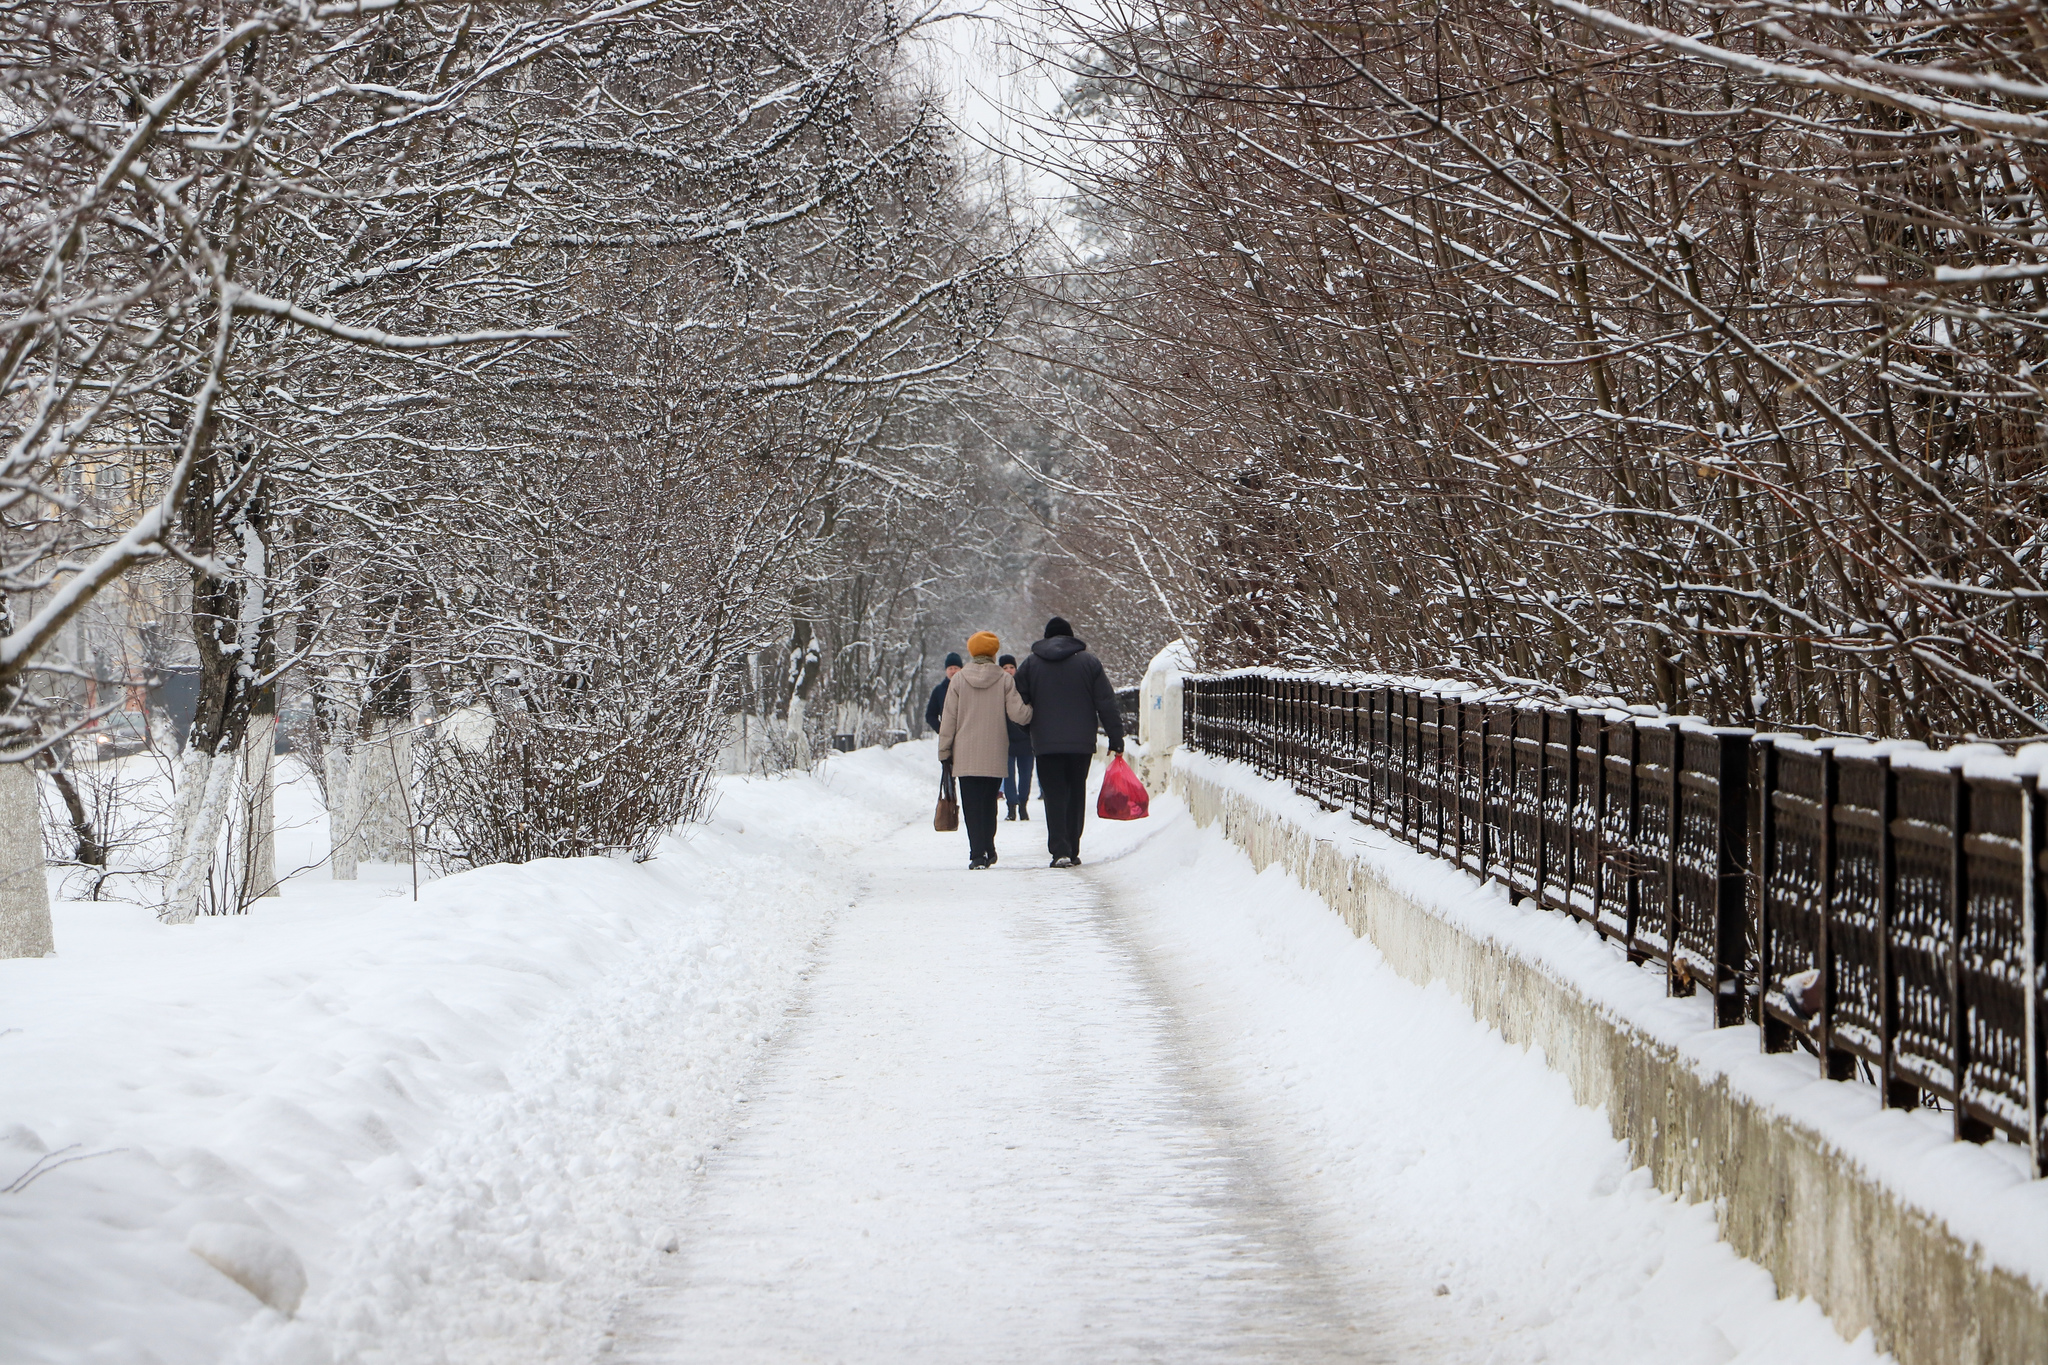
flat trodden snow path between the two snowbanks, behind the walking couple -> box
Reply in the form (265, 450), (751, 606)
(614, 806), (1384, 1365)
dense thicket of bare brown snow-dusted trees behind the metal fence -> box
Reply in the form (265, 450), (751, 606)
(1024, 0), (2048, 735)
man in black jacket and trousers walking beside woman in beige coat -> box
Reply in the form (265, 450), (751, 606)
(1018, 616), (1124, 868)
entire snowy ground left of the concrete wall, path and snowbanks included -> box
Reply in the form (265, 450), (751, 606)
(0, 743), (1874, 1365)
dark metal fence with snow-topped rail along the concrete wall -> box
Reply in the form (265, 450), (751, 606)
(1182, 673), (2048, 1175)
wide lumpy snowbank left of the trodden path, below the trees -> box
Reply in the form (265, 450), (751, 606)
(0, 745), (934, 1365)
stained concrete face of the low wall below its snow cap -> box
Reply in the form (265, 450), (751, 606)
(1171, 755), (2048, 1365)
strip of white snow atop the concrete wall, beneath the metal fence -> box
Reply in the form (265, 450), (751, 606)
(1174, 747), (2048, 1291)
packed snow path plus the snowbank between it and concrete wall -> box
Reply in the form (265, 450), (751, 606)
(606, 757), (1882, 1365)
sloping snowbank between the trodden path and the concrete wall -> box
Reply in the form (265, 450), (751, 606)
(1100, 773), (1888, 1365)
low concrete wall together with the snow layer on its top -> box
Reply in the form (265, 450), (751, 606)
(1169, 749), (2048, 1365)
